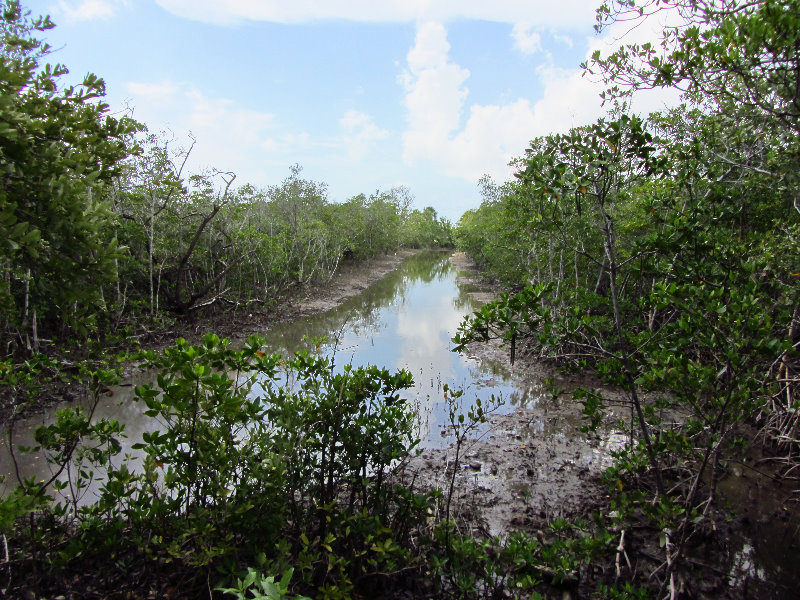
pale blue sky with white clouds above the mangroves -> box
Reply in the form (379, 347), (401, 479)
(22, 0), (669, 223)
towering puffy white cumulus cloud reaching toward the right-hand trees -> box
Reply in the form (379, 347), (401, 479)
(399, 18), (678, 181)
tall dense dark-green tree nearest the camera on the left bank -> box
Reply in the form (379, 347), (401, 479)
(0, 2), (134, 353)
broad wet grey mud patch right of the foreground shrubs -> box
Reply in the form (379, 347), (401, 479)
(404, 408), (605, 536)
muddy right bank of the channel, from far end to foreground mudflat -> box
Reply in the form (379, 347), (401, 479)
(403, 252), (608, 536)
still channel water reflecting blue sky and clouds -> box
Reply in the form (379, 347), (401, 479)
(0, 252), (529, 493)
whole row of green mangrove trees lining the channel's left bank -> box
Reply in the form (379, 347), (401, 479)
(0, 1), (452, 356)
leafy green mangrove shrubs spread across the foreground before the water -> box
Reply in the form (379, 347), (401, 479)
(0, 334), (613, 600)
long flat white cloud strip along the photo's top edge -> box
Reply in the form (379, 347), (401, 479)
(156, 0), (599, 27)
